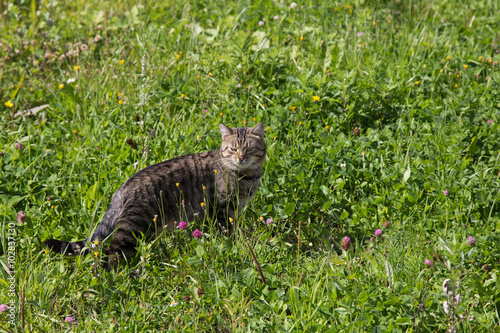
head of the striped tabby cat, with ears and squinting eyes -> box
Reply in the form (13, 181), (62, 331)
(219, 122), (266, 171)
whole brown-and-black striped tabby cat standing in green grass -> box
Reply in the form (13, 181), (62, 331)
(45, 122), (266, 270)
